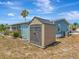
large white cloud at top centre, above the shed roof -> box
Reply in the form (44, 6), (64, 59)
(35, 0), (54, 13)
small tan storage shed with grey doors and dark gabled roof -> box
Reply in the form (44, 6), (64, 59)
(29, 17), (56, 48)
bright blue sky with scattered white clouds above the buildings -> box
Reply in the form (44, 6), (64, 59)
(0, 0), (79, 24)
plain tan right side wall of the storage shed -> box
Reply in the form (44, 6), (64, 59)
(44, 24), (56, 46)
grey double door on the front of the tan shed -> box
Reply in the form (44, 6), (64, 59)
(30, 25), (42, 45)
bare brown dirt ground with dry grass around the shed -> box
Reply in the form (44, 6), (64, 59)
(0, 35), (79, 59)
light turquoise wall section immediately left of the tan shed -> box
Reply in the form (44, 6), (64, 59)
(21, 25), (29, 41)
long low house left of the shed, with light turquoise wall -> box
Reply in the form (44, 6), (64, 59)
(10, 22), (30, 41)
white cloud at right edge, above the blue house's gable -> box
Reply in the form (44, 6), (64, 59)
(59, 11), (79, 20)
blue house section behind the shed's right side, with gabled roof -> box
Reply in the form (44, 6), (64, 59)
(54, 19), (69, 37)
